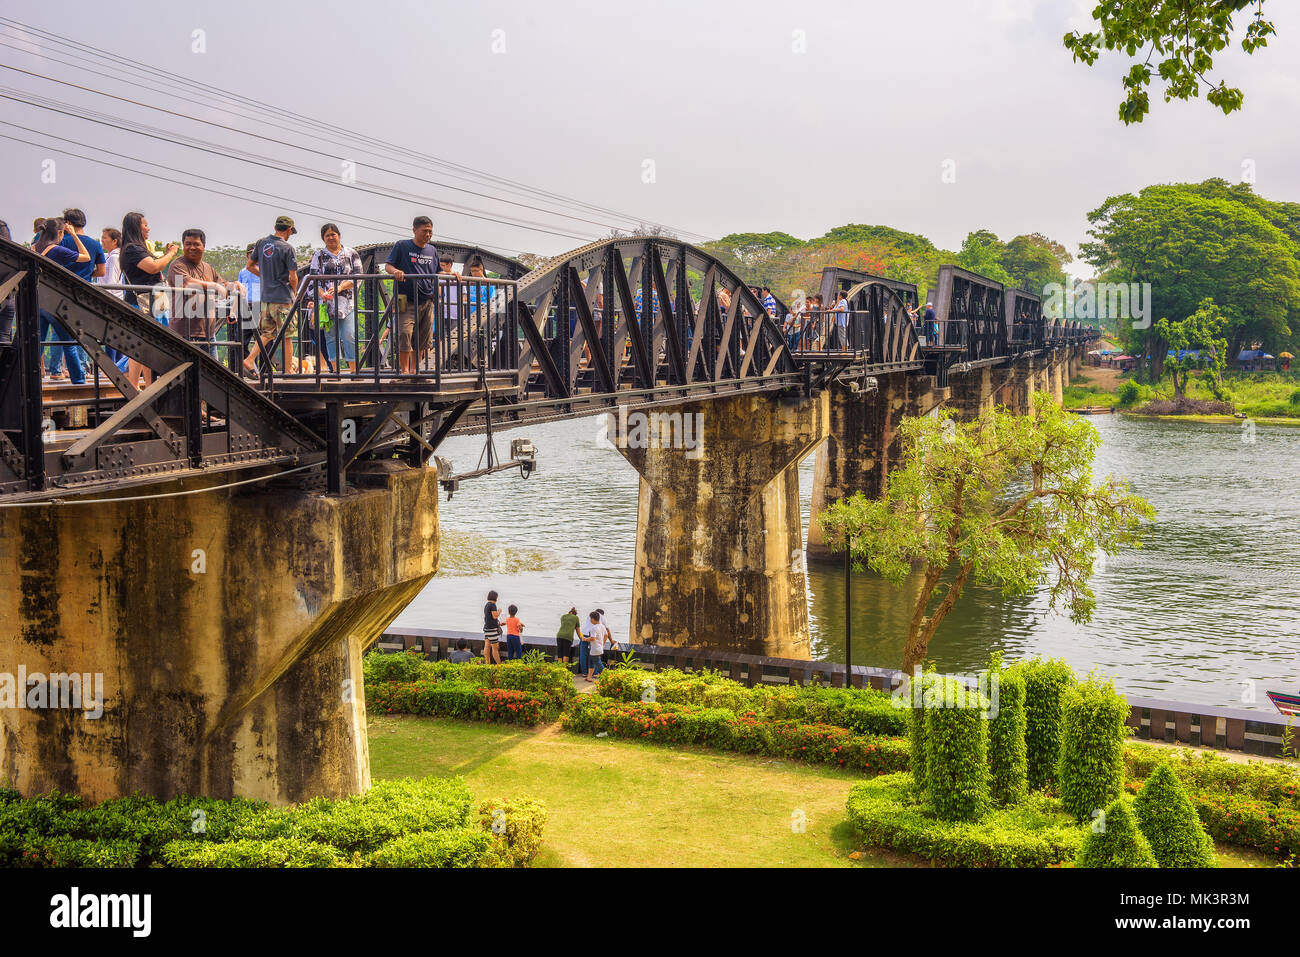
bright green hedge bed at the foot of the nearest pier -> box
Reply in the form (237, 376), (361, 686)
(0, 778), (546, 867)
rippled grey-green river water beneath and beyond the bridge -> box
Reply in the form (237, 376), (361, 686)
(395, 415), (1300, 711)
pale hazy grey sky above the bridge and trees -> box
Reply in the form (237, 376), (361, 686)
(0, 0), (1300, 276)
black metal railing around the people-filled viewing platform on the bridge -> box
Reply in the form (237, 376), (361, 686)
(254, 273), (520, 393)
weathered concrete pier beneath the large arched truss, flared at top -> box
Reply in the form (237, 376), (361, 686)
(616, 393), (829, 658)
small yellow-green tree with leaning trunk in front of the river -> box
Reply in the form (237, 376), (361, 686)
(822, 393), (1154, 675)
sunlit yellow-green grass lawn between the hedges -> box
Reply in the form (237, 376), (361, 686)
(369, 715), (898, 867)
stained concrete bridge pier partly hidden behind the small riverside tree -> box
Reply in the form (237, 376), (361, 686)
(807, 372), (948, 559)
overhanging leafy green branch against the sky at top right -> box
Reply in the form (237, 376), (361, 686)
(1063, 0), (1277, 125)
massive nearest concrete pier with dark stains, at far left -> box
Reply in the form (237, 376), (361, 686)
(0, 468), (438, 804)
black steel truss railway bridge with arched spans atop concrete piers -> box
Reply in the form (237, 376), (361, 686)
(0, 238), (1095, 503)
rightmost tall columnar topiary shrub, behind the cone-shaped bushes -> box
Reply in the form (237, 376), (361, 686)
(1057, 679), (1128, 820)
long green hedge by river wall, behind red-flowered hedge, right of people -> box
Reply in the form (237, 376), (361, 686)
(595, 668), (907, 735)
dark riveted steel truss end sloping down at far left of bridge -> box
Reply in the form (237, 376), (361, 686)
(0, 241), (325, 498)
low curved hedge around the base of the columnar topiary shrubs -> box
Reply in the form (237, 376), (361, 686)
(848, 774), (1087, 867)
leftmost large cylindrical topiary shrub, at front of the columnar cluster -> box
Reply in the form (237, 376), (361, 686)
(924, 677), (989, 820)
